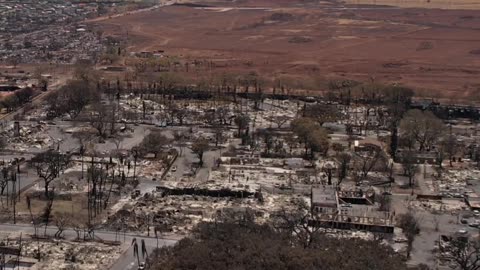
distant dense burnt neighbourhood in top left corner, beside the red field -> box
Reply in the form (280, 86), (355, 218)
(0, 1), (113, 63)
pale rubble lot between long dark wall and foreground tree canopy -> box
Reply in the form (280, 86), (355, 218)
(105, 188), (293, 235)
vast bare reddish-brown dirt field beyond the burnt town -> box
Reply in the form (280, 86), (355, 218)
(92, 0), (480, 100)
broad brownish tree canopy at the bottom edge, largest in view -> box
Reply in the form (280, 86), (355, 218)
(149, 218), (407, 270)
